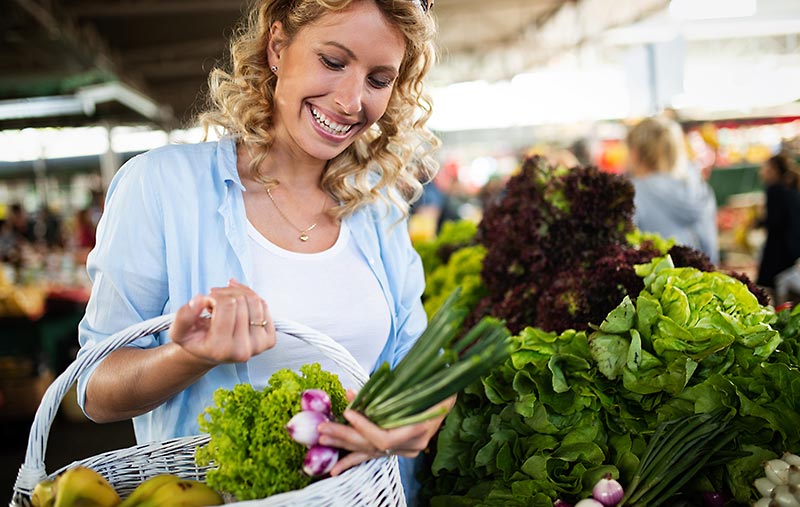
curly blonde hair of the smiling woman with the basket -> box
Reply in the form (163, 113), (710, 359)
(199, 0), (439, 218)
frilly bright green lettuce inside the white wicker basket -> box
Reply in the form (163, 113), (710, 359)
(195, 363), (347, 501)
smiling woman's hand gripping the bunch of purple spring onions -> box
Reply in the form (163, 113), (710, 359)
(318, 391), (456, 476)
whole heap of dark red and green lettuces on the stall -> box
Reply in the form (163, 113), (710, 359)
(422, 158), (800, 507)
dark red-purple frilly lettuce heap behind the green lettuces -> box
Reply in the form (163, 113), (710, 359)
(473, 156), (659, 333)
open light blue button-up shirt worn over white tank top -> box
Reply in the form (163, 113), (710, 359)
(78, 138), (427, 496)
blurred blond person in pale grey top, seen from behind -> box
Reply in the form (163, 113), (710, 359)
(627, 117), (719, 264)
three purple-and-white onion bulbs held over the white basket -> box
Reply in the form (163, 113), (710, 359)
(286, 389), (339, 477)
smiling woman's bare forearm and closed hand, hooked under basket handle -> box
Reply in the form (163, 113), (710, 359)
(84, 280), (275, 422)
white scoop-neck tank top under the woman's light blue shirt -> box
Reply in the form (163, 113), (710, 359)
(247, 221), (391, 389)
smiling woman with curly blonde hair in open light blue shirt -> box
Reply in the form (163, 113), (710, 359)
(78, 0), (444, 500)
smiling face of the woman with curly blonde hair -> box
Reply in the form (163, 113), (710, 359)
(269, 0), (405, 165)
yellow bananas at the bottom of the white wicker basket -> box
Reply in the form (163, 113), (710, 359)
(31, 466), (222, 507)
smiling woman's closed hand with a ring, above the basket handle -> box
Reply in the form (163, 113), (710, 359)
(169, 280), (275, 367)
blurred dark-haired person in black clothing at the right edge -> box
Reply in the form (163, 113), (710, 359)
(757, 154), (800, 289)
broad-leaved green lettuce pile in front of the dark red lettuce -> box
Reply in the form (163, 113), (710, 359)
(428, 257), (800, 505)
